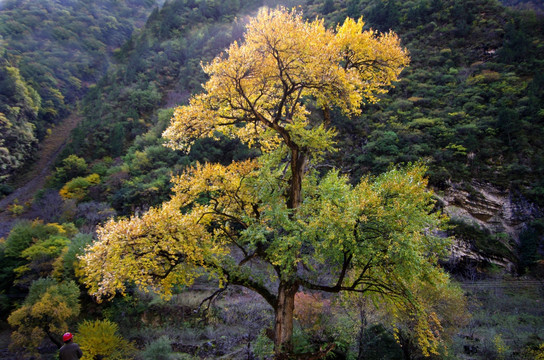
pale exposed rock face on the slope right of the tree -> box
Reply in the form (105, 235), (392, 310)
(438, 182), (543, 271)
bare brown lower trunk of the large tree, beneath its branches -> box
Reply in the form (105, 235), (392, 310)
(274, 281), (298, 360)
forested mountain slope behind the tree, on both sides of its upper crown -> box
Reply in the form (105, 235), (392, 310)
(51, 0), (544, 214)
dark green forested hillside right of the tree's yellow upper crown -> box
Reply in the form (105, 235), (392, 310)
(306, 1), (544, 197)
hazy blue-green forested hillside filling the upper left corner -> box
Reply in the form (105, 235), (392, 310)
(0, 0), (157, 182)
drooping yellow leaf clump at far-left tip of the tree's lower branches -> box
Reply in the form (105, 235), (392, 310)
(83, 204), (209, 300)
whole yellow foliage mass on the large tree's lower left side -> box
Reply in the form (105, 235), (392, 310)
(82, 161), (256, 301)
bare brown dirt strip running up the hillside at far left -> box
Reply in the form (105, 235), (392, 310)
(0, 112), (81, 238)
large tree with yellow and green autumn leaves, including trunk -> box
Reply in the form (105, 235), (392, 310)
(83, 9), (447, 358)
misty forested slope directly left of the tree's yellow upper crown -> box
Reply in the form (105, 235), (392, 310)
(57, 1), (276, 214)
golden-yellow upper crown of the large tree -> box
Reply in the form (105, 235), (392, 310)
(163, 8), (409, 153)
